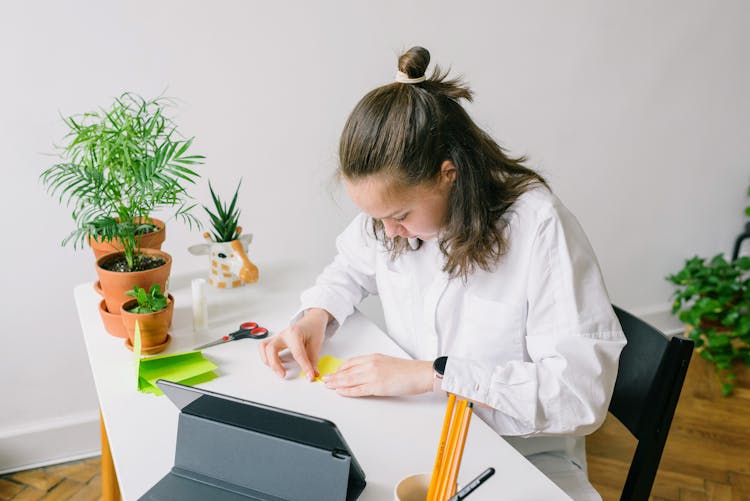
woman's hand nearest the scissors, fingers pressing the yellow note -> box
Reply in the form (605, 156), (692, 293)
(258, 308), (332, 381)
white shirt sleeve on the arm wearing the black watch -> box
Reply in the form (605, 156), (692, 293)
(442, 201), (625, 436)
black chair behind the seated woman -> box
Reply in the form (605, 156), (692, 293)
(609, 306), (693, 501)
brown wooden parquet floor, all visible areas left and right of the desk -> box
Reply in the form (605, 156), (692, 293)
(0, 356), (750, 501)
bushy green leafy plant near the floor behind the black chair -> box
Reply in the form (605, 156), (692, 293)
(666, 254), (750, 396)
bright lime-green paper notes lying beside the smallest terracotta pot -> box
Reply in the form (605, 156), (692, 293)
(133, 322), (217, 395)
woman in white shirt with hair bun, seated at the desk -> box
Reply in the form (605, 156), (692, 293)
(259, 47), (625, 499)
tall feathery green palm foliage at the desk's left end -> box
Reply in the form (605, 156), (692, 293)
(40, 93), (204, 270)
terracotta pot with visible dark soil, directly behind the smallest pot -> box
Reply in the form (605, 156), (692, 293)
(96, 249), (172, 311)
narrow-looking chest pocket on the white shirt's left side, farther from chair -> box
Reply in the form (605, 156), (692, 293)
(377, 268), (417, 357)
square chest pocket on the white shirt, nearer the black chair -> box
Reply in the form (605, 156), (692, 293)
(459, 293), (527, 365)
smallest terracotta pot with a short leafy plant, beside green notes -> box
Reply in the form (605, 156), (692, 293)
(121, 284), (174, 355)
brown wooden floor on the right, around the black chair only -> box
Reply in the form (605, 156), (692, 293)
(586, 353), (750, 501)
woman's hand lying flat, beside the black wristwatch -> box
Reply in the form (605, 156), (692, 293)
(323, 354), (433, 397)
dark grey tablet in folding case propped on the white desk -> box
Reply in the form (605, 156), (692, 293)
(140, 380), (365, 501)
